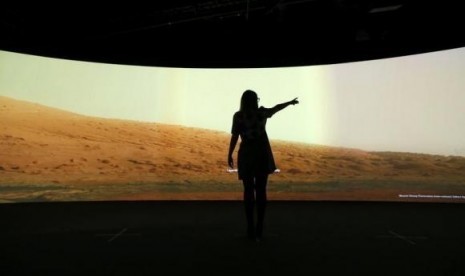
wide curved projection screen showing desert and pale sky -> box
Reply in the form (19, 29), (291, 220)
(0, 48), (465, 202)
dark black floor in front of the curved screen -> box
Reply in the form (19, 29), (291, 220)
(0, 201), (465, 276)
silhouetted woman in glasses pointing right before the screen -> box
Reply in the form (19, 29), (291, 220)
(228, 90), (299, 241)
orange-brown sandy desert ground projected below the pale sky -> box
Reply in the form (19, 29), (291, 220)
(0, 96), (465, 202)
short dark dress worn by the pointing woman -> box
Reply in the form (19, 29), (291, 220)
(231, 107), (276, 180)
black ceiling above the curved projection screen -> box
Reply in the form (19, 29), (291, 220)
(0, 0), (465, 68)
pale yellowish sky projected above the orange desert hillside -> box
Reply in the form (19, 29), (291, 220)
(0, 48), (465, 156)
